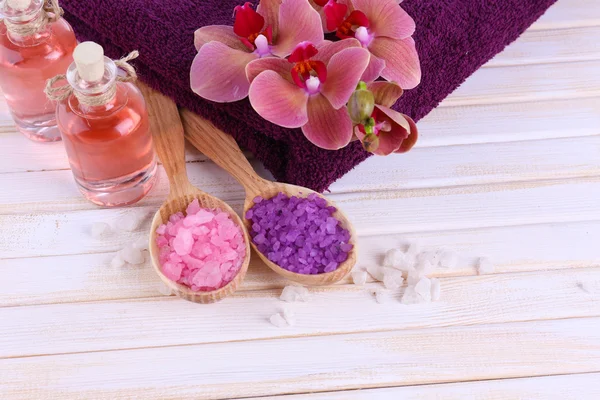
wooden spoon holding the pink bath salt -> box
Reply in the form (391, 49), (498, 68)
(140, 85), (250, 304)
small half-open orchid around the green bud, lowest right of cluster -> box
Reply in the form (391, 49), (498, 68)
(354, 82), (419, 156)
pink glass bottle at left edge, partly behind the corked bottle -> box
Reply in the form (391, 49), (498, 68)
(0, 0), (77, 142)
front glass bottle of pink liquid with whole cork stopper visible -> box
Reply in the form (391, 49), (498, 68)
(56, 42), (157, 207)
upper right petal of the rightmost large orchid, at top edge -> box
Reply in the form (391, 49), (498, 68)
(352, 0), (415, 39)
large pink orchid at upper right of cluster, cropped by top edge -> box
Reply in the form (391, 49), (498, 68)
(311, 0), (421, 89)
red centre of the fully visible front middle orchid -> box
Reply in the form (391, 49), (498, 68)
(288, 42), (327, 94)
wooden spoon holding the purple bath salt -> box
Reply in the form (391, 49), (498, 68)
(181, 110), (357, 286)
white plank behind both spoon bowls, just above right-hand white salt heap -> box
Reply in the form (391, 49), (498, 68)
(0, 177), (600, 258)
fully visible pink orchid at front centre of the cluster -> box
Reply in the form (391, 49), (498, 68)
(246, 39), (369, 150)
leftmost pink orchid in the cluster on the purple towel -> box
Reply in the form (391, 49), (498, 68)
(190, 0), (323, 103)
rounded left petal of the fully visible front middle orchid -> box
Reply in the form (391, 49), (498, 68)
(250, 71), (308, 128)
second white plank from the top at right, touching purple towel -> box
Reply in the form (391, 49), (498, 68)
(484, 25), (600, 68)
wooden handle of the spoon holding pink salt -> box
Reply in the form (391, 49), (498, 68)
(140, 84), (191, 197)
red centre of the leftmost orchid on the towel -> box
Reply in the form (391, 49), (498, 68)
(233, 3), (273, 57)
